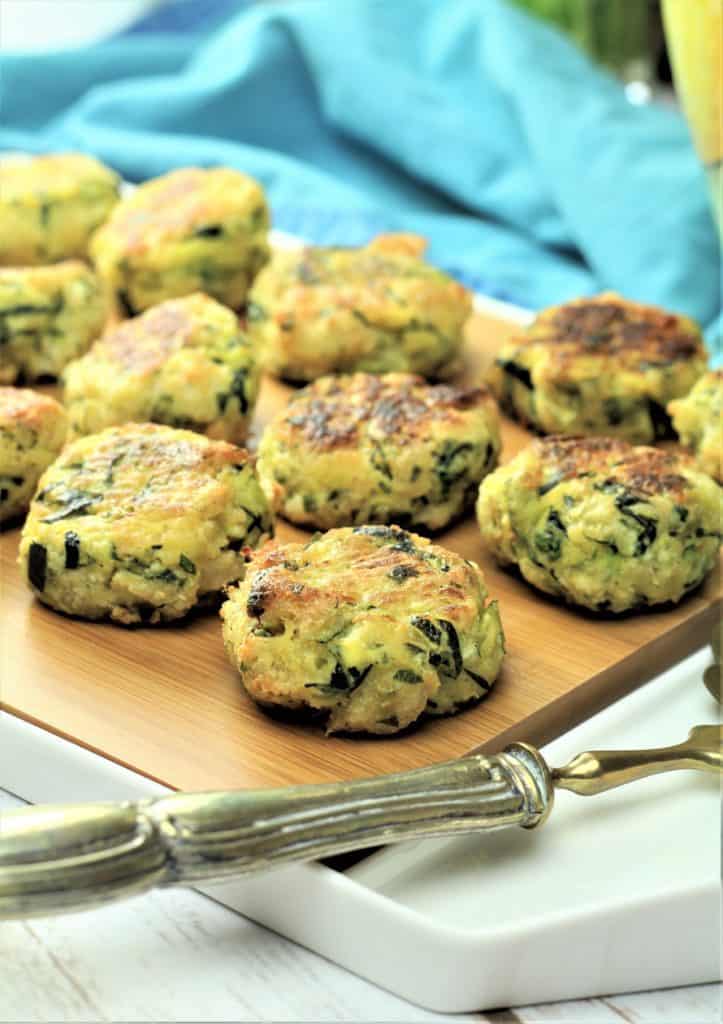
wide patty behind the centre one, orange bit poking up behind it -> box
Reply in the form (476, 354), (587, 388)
(248, 234), (472, 381)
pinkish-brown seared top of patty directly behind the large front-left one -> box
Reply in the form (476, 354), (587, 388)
(100, 302), (194, 373)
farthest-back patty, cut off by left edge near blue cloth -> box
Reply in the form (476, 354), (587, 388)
(0, 153), (120, 266)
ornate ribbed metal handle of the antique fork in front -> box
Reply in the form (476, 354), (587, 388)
(0, 743), (553, 918)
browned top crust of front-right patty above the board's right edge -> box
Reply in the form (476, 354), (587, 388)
(533, 435), (694, 499)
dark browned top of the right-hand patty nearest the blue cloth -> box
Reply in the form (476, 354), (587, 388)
(515, 293), (705, 365)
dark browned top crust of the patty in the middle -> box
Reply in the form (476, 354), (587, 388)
(282, 374), (493, 451)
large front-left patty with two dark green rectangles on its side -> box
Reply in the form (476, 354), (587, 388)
(20, 423), (271, 624)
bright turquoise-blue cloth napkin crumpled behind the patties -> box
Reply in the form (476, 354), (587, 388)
(0, 0), (721, 356)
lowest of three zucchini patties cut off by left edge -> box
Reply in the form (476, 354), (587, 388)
(0, 387), (68, 522)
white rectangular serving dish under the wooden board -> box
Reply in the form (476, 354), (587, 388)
(0, 651), (721, 1012)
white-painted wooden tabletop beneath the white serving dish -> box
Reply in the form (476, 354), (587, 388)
(0, 790), (721, 1024)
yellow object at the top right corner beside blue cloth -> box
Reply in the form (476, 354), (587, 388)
(663, 0), (723, 233)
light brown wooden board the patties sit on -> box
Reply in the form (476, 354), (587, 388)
(0, 314), (721, 790)
